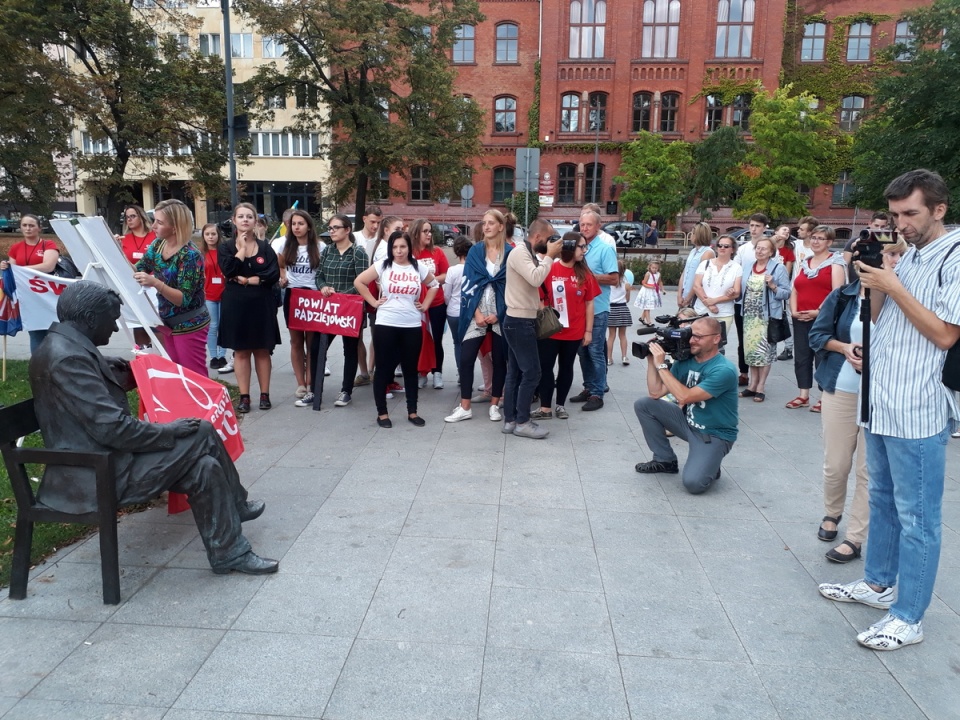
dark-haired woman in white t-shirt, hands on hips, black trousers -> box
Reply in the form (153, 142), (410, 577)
(353, 231), (439, 428)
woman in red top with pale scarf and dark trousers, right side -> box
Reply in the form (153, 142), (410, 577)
(786, 225), (847, 412)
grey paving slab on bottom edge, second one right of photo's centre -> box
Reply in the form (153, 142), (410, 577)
(620, 657), (776, 720)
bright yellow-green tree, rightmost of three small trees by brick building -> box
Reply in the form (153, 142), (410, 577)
(733, 85), (837, 219)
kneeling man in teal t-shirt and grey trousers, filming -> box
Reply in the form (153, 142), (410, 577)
(633, 318), (738, 495)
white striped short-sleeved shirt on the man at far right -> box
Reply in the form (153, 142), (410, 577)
(861, 231), (960, 439)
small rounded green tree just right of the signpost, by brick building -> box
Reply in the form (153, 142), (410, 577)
(614, 132), (693, 220)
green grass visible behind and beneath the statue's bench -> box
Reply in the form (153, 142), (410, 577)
(0, 360), (147, 587)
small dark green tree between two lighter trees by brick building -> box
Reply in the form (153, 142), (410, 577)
(691, 126), (747, 220)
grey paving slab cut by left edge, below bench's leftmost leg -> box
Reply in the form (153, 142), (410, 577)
(0, 618), (97, 697)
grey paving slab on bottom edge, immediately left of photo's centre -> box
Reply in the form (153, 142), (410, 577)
(323, 639), (483, 720)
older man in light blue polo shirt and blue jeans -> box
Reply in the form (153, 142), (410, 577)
(570, 210), (620, 410)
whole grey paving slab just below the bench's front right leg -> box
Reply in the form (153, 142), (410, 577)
(30, 624), (223, 707)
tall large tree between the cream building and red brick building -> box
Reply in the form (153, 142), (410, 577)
(235, 0), (483, 222)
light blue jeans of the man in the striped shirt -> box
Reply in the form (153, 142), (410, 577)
(864, 428), (950, 623)
